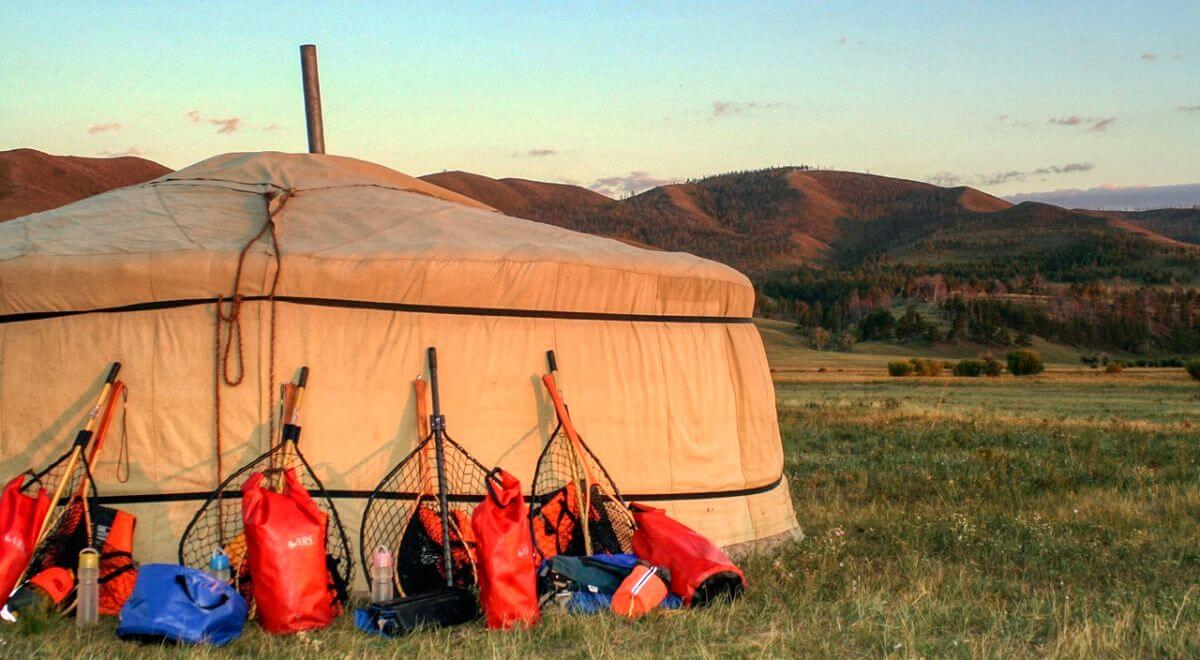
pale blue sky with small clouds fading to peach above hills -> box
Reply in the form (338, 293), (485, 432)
(0, 0), (1200, 208)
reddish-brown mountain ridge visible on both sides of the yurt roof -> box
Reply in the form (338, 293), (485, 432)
(0, 149), (1200, 275)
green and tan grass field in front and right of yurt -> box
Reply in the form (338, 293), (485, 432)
(0, 328), (1200, 658)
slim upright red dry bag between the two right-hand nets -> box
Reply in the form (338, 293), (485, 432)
(470, 468), (541, 630)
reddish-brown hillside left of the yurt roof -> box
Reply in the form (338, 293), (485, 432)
(0, 149), (170, 221)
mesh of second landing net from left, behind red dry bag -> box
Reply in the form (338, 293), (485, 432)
(179, 442), (354, 602)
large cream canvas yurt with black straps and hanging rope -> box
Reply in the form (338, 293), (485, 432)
(0, 152), (797, 583)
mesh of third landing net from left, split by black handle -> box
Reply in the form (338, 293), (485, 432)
(359, 434), (488, 595)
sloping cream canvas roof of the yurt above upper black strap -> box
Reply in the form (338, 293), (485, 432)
(0, 152), (754, 320)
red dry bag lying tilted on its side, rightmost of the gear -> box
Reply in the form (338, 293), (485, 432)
(631, 504), (746, 607)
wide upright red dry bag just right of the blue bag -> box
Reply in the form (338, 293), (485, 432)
(241, 469), (341, 635)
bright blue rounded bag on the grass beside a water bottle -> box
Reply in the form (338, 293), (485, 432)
(116, 564), (246, 646)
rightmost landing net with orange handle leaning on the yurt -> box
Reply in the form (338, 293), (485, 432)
(529, 350), (635, 559)
